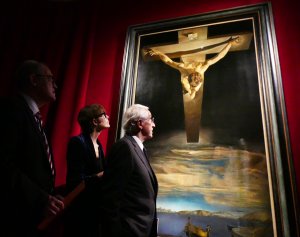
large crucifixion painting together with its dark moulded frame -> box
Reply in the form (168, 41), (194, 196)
(117, 3), (299, 237)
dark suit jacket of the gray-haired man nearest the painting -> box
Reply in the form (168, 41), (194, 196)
(100, 136), (158, 237)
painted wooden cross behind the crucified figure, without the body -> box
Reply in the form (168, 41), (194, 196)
(143, 27), (253, 143)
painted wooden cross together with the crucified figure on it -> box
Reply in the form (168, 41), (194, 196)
(143, 27), (252, 142)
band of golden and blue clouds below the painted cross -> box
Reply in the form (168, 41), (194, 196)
(151, 131), (270, 215)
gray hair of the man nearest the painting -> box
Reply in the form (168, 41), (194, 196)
(123, 104), (151, 135)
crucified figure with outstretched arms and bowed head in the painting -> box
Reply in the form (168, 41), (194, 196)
(146, 37), (239, 99)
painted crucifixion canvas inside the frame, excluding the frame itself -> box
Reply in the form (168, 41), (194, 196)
(135, 20), (273, 237)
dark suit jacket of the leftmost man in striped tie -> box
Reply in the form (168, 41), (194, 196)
(0, 96), (54, 236)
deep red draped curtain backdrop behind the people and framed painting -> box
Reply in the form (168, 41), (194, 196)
(0, 0), (300, 206)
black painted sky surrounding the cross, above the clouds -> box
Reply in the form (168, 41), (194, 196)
(135, 20), (263, 149)
